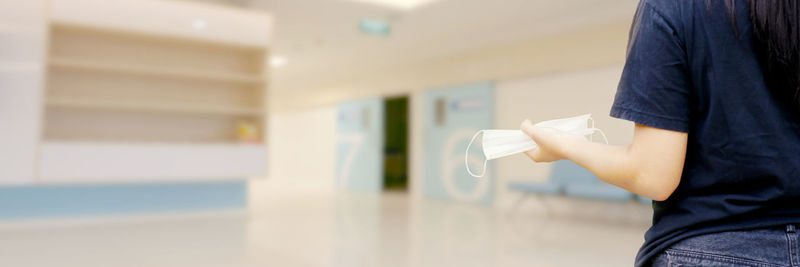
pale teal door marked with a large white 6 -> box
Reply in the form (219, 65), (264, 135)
(423, 82), (494, 203)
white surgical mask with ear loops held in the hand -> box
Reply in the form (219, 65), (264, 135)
(464, 114), (608, 178)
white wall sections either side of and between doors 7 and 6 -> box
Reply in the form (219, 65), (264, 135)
(262, 65), (633, 206)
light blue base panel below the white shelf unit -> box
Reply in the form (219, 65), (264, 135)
(0, 181), (247, 220)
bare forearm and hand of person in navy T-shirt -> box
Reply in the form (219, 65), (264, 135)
(521, 120), (688, 201)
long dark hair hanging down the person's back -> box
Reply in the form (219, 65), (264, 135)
(724, 0), (800, 110)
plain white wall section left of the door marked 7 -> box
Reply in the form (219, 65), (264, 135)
(249, 106), (336, 209)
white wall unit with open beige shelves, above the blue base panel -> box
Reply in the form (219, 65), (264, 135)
(0, 0), (273, 185)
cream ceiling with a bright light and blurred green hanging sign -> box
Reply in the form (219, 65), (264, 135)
(197, 0), (638, 92)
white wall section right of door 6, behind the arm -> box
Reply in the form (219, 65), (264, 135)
(494, 66), (633, 205)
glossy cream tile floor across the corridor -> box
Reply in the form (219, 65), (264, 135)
(0, 194), (647, 267)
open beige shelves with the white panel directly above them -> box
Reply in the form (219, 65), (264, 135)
(43, 0), (272, 151)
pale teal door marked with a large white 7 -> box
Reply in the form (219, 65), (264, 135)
(336, 98), (383, 192)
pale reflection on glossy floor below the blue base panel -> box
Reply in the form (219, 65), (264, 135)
(0, 216), (247, 267)
